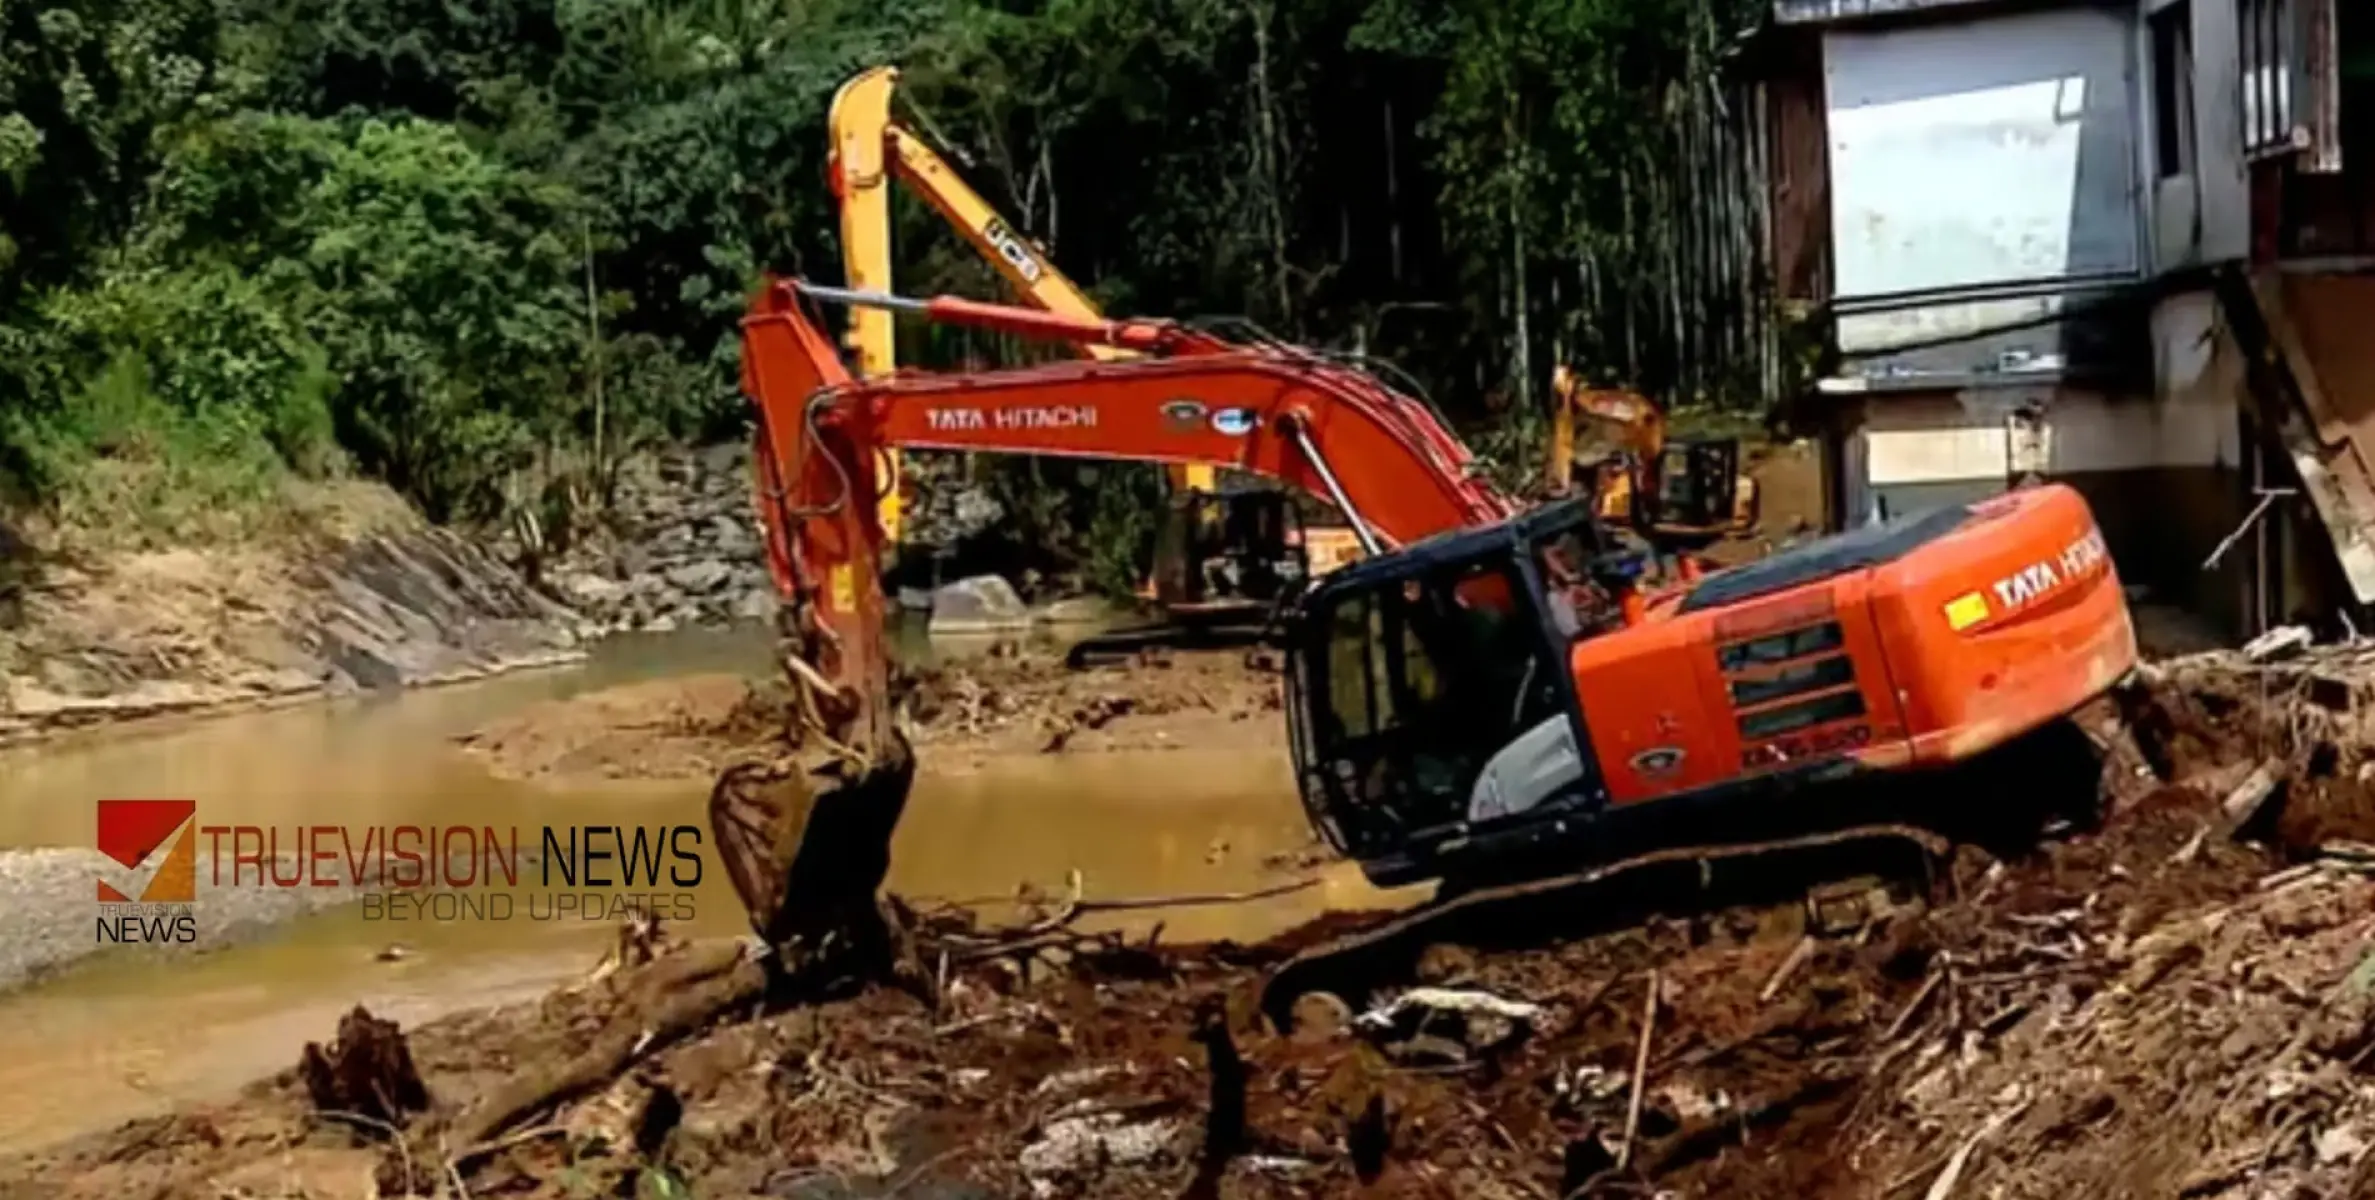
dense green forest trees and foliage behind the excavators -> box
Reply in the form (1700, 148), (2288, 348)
(0, 0), (1753, 546)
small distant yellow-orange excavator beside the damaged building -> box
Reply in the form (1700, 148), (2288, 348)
(1546, 366), (1758, 554)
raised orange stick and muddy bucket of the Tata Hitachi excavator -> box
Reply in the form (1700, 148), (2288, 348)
(710, 283), (914, 974)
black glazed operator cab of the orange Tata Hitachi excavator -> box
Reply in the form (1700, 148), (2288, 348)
(1287, 499), (1641, 884)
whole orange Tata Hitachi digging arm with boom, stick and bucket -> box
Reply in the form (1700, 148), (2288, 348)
(710, 280), (1515, 941)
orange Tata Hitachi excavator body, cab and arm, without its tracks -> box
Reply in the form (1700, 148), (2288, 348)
(713, 280), (2138, 960)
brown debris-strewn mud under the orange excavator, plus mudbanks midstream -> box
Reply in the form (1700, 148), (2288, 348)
(18, 632), (2375, 1200)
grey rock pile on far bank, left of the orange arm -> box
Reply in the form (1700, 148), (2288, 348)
(551, 442), (774, 632)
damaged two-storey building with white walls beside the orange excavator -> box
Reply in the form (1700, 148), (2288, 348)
(1743, 0), (2375, 644)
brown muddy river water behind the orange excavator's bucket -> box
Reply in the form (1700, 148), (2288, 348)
(0, 634), (1406, 1150)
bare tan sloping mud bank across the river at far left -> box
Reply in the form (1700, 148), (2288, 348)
(0, 487), (582, 746)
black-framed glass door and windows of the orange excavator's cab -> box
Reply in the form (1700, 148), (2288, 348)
(1318, 561), (1563, 853)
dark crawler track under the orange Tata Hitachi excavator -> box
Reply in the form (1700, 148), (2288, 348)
(1261, 825), (1952, 1031)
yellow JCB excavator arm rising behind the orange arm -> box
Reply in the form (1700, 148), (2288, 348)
(829, 67), (1214, 542)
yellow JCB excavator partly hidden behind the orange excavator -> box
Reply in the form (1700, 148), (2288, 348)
(827, 67), (1361, 663)
